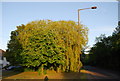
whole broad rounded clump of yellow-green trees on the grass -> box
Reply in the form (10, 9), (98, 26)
(6, 20), (88, 72)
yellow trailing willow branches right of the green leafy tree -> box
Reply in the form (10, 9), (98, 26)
(49, 21), (88, 72)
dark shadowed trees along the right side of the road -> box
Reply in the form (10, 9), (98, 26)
(89, 21), (120, 70)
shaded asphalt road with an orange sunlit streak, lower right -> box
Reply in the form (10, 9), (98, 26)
(84, 66), (120, 80)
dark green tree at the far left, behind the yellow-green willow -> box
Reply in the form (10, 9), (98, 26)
(5, 31), (23, 65)
